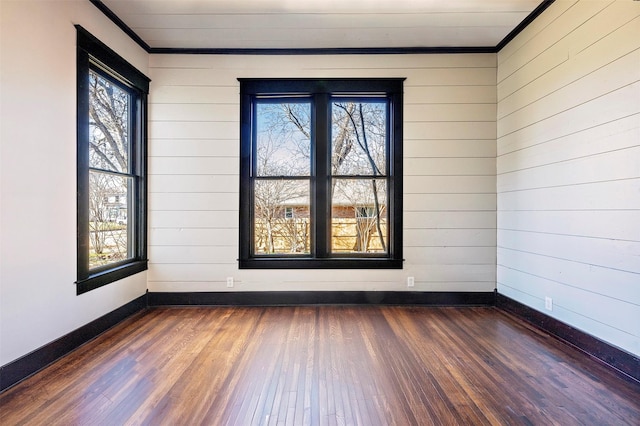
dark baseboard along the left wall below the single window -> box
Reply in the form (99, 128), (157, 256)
(0, 294), (147, 392)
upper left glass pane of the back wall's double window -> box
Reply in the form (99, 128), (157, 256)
(256, 102), (311, 176)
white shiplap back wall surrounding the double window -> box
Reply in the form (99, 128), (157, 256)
(148, 54), (496, 292)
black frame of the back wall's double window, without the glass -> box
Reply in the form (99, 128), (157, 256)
(238, 78), (405, 269)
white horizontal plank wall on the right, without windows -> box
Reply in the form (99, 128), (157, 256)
(497, 0), (640, 356)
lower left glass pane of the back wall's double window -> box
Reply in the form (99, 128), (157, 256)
(254, 179), (310, 255)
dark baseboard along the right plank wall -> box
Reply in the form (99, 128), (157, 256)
(496, 293), (640, 383)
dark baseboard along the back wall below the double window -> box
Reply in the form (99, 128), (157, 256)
(148, 291), (495, 306)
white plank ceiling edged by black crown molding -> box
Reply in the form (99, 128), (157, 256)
(97, 0), (541, 49)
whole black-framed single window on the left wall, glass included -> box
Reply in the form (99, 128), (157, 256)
(76, 26), (149, 294)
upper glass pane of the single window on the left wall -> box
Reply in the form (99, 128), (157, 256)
(89, 71), (130, 173)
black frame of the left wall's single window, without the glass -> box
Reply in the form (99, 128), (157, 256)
(75, 25), (150, 295)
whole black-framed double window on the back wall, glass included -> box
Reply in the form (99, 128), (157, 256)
(239, 79), (404, 269)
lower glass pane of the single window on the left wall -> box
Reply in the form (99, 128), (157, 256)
(89, 171), (132, 269)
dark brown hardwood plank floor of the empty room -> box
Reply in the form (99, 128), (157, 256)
(0, 306), (640, 425)
